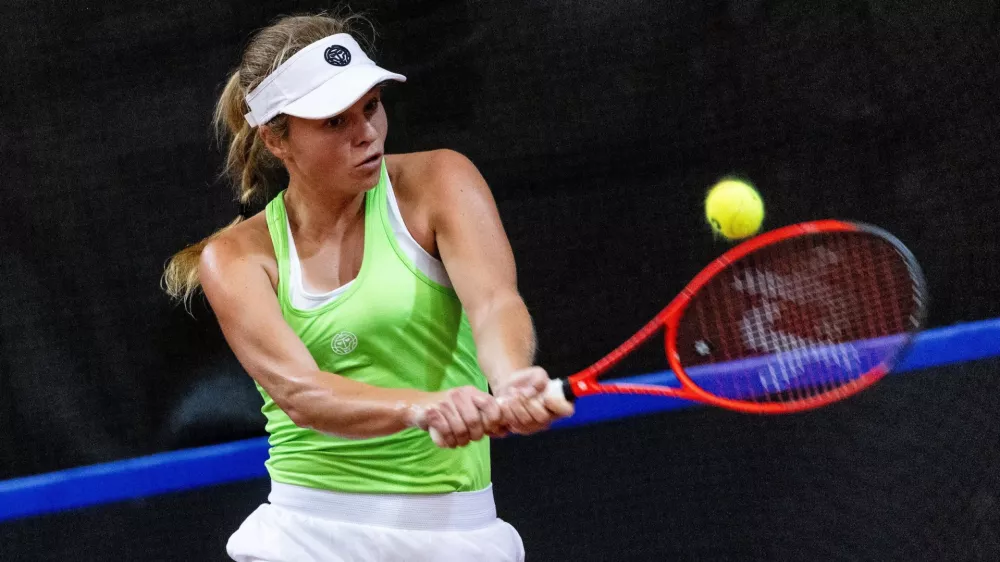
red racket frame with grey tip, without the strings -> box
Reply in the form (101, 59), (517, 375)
(561, 220), (925, 414)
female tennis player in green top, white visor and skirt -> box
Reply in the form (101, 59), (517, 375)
(164, 9), (572, 562)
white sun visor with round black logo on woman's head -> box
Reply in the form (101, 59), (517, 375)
(245, 33), (406, 127)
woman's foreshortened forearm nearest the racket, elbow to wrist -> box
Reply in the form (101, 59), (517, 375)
(473, 294), (535, 389)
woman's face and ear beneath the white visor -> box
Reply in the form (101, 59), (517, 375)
(261, 87), (388, 194)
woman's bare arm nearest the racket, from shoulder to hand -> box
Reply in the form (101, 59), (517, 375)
(424, 150), (572, 433)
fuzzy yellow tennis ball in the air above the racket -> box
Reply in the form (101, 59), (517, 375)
(705, 179), (764, 240)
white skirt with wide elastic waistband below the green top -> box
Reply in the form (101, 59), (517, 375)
(226, 476), (524, 562)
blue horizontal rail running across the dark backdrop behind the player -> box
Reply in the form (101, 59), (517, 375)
(0, 318), (1000, 522)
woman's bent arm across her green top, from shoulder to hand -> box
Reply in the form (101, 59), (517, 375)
(198, 225), (502, 447)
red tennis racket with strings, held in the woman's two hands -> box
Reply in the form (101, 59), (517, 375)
(547, 220), (927, 414)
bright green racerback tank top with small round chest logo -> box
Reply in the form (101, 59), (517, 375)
(257, 162), (490, 494)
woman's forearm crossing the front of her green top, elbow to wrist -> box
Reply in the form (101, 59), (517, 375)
(279, 371), (430, 439)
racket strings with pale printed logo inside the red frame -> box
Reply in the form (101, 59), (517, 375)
(677, 232), (920, 403)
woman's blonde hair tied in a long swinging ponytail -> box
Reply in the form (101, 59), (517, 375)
(162, 9), (374, 306)
